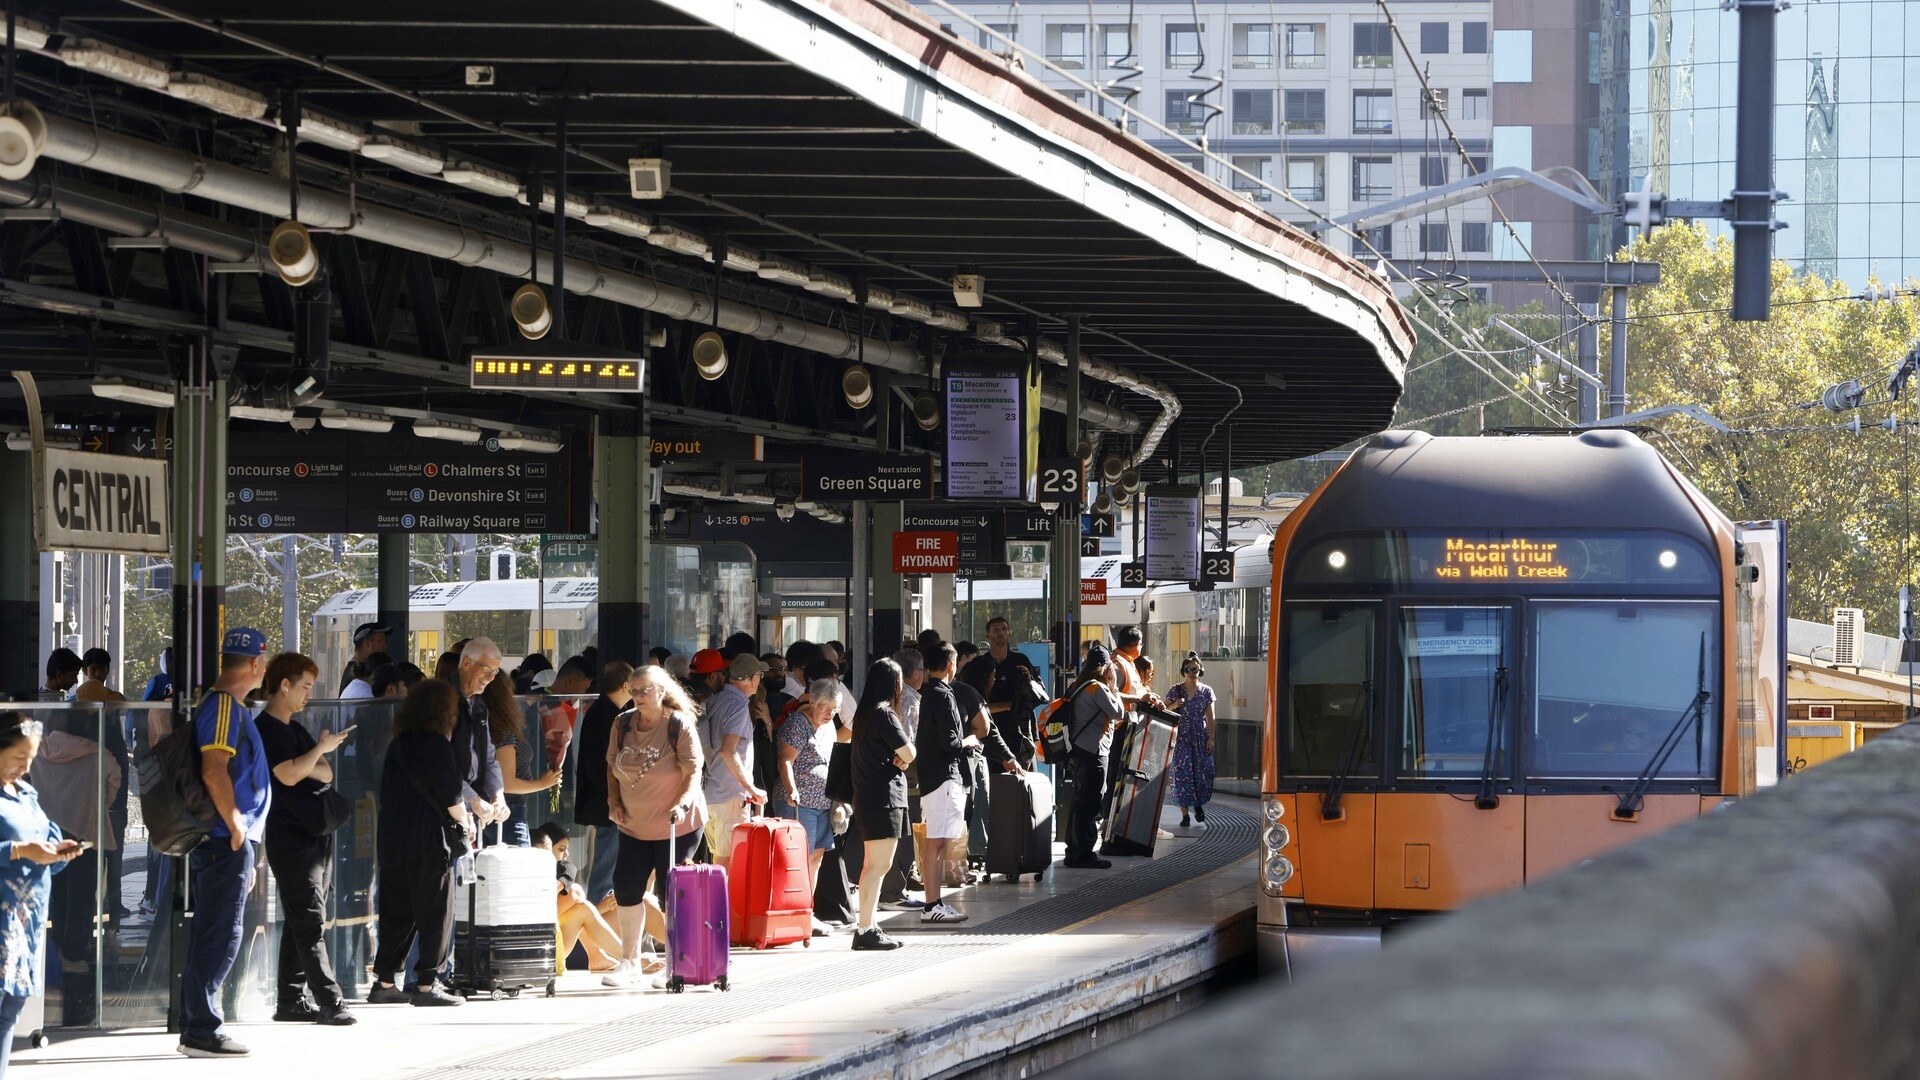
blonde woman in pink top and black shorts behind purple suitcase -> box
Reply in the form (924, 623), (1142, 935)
(603, 665), (707, 986)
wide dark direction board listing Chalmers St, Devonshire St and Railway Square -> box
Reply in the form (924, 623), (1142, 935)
(227, 430), (591, 532)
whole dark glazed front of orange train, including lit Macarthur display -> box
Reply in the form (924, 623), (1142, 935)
(1277, 530), (1722, 786)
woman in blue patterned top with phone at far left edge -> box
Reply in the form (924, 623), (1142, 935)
(0, 713), (84, 1076)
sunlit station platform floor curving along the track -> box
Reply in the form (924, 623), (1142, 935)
(13, 796), (1258, 1080)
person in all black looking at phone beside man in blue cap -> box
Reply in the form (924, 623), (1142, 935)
(259, 653), (353, 1026)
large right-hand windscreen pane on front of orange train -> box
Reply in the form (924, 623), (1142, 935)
(1526, 601), (1720, 780)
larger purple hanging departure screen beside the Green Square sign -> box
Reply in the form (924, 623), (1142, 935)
(941, 354), (1041, 502)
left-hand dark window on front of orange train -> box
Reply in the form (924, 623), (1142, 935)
(1286, 603), (1379, 776)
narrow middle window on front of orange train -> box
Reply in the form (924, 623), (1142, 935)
(1396, 607), (1513, 778)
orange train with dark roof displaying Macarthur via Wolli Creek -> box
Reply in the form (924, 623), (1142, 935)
(1260, 430), (1786, 970)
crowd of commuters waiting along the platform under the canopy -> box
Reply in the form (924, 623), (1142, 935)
(0, 619), (1215, 1070)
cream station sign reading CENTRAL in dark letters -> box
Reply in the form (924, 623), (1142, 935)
(33, 450), (171, 555)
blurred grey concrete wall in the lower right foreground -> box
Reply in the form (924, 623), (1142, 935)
(1066, 724), (1920, 1080)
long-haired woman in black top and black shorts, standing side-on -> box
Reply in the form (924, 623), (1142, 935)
(852, 659), (914, 949)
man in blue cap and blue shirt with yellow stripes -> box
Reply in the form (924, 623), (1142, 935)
(180, 626), (273, 1057)
